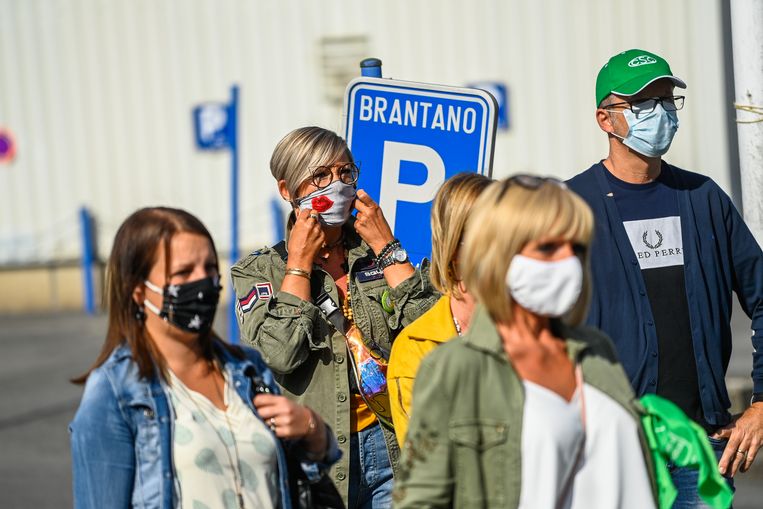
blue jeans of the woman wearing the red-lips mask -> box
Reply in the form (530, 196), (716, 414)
(348, 423), (392, 509)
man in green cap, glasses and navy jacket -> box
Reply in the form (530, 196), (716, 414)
(568, 49), (763, 503)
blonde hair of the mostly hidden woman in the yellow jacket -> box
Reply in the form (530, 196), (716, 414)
(429, 173), (492, 297)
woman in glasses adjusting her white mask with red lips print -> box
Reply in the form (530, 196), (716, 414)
(231, 127), (436, 508)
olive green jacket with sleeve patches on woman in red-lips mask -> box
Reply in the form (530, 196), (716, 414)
(231, 221), (438, 505)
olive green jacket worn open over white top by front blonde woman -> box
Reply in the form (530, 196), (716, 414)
(394, 307), (654, 508)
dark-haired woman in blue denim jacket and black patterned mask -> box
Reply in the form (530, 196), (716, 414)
(69, 207), (340, 509)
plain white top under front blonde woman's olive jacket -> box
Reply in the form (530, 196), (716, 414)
(519, 380), (654, 509)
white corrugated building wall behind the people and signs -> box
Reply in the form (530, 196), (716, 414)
(0, 0), (730, 265)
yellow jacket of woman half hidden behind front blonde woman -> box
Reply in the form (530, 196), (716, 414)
(387, 295), (458, 447)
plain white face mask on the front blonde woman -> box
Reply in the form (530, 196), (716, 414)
(506, 255), (583, 318)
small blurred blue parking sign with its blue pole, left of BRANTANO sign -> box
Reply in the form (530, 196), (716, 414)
(193, 85), (239, 343)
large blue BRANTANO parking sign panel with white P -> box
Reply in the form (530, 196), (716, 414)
(345, 77), (497, 263)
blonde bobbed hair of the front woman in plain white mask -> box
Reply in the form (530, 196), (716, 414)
(461, 178), (594, 325)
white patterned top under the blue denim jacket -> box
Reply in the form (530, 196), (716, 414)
(169, 371), (280, 509)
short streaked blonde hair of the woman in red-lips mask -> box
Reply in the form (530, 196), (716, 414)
(270, 126), (353, 201)
